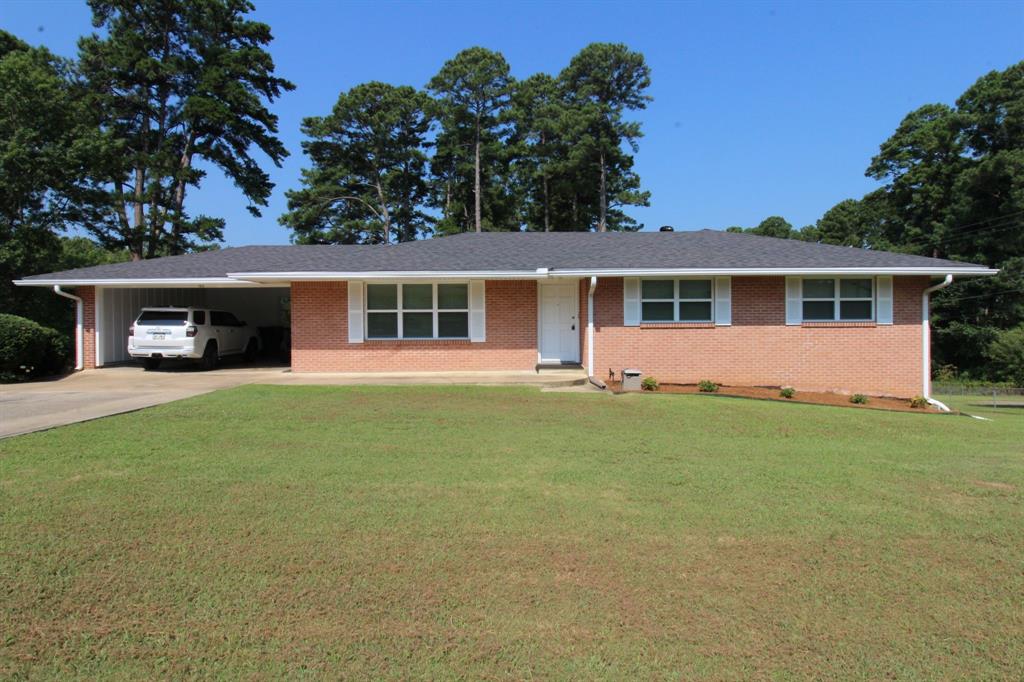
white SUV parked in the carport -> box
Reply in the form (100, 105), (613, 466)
(128, 307), (259, 370)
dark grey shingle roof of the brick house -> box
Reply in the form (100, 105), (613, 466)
(16, 229), (984, 282)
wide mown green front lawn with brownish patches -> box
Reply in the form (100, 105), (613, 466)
(0, 386), (1024, 679)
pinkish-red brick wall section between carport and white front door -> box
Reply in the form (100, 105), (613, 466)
(292, 280), (537, 372)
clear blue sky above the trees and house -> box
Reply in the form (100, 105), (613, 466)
(0, 0), (1024, 246)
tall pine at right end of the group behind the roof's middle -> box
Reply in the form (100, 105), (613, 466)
(559, 43), (650, 232)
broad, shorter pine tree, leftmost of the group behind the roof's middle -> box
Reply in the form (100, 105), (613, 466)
(281, 82), (430, 244)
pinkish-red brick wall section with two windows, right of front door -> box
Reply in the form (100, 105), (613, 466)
(582, 276), (929, 396)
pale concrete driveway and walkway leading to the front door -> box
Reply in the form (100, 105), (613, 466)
(0, 366), (586, 438)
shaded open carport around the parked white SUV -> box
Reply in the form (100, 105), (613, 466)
(95, 283), (291, 367)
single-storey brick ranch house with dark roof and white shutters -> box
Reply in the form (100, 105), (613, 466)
(16, 230), (994, 397)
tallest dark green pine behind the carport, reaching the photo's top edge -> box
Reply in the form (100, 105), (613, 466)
(79, 0), (294, 259)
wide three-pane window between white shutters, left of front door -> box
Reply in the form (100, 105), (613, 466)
(367, 284), (469, 339)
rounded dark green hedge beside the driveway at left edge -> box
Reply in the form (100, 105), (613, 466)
(0, 313), (70, 383)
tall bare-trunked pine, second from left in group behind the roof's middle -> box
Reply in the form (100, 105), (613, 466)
(427, 47), (513, 232)
